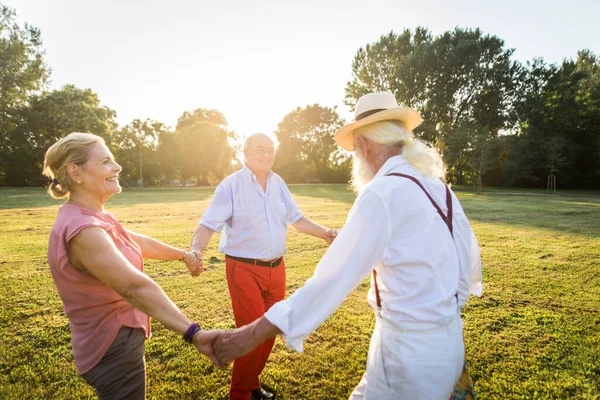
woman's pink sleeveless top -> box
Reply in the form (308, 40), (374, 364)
(48, 203), (150, 374)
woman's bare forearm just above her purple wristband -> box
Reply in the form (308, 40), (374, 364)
(122, 278), (191, 335)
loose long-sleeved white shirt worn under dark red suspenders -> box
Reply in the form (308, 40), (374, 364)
(265, 156), (482, 351)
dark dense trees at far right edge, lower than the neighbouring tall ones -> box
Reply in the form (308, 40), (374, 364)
(506, 50), (600, 188)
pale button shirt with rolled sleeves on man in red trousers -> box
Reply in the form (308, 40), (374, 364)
(200, 165), (302, 260)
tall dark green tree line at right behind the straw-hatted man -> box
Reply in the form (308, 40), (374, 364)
(345, 27), (600, 188)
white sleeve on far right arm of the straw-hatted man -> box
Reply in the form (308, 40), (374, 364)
(452, 193), (483, 306)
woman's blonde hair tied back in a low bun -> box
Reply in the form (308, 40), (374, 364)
(42, 132), (104, 199)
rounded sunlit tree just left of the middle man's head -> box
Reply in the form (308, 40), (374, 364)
(175, 108), (236, 185)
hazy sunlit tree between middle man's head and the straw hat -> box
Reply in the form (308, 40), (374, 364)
(275, 104), (344, 182)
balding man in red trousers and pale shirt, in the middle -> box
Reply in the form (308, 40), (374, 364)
(192, 133), (337, 400)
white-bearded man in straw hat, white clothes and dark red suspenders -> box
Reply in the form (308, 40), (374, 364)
(214, 93), (482, 400)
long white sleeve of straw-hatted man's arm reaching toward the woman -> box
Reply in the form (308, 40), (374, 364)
(265, 190), (391, 351)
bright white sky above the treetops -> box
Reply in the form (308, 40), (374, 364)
(5, 0), (600, 141)
